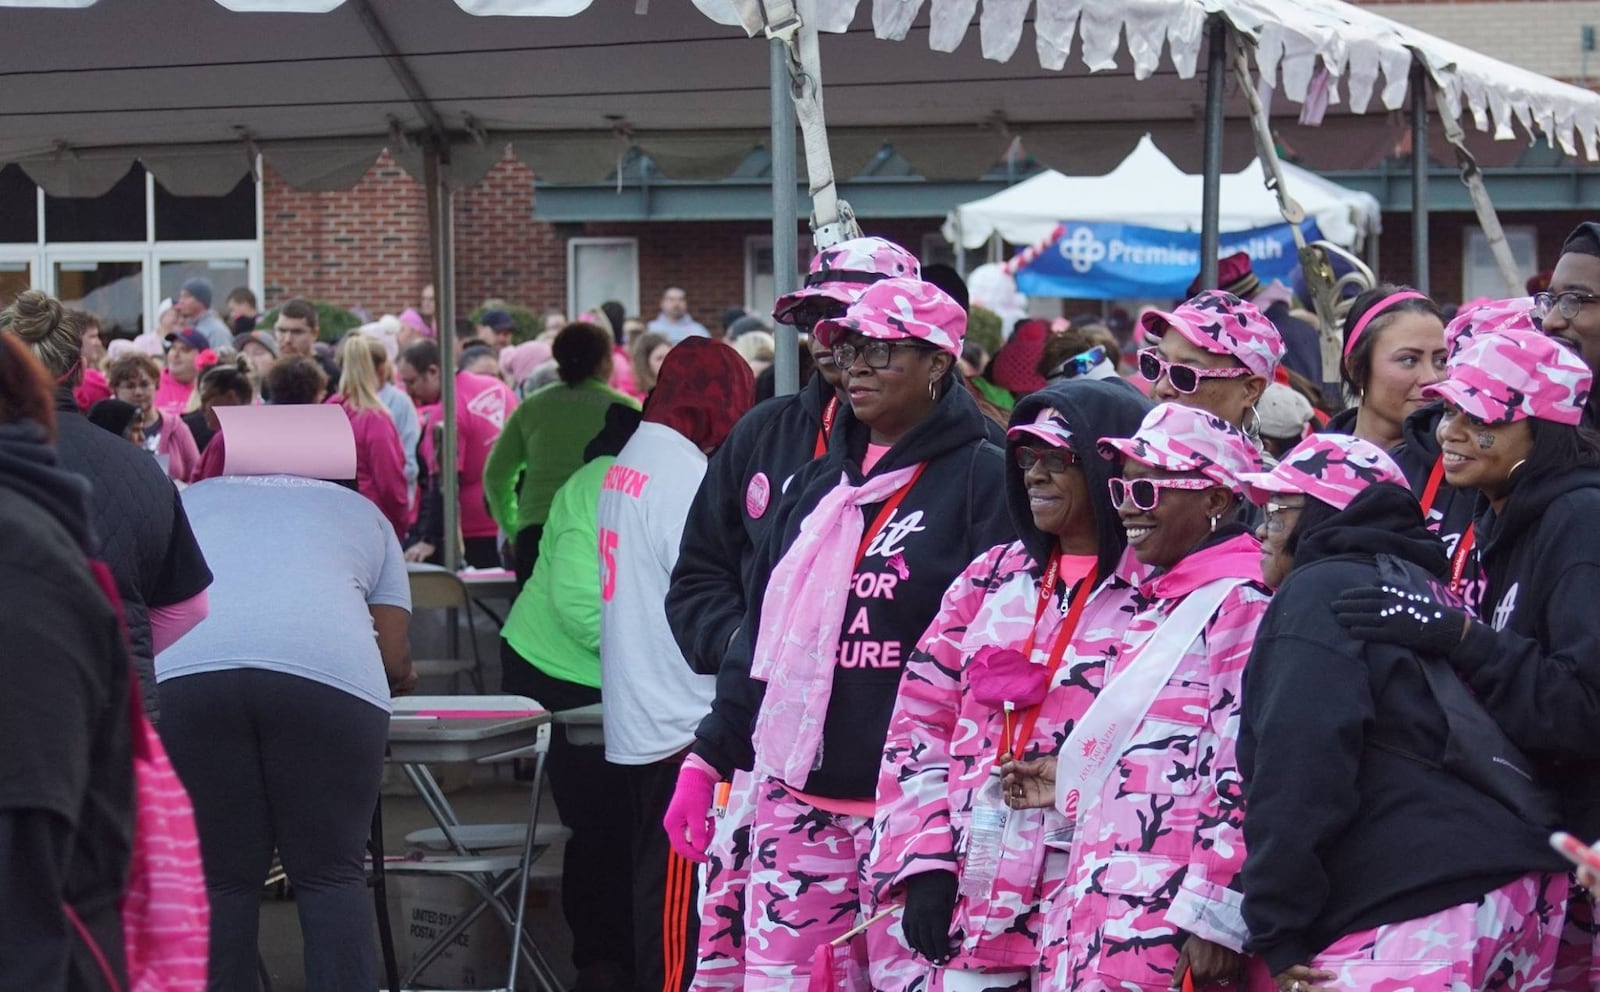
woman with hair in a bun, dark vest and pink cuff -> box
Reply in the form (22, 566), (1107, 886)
(0, 290), (211, 722)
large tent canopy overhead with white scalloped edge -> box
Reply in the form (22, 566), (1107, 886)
(0, 0), (1600, 195)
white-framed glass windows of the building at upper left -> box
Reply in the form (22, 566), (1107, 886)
(0, 163), (264, 341)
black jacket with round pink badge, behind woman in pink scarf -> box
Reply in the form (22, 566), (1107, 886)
(667, 376), (834, 675)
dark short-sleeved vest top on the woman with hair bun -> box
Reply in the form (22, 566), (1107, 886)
(56, 390), (211, 720)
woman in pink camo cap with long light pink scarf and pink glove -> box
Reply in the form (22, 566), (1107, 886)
(666, 277), (1011, 992)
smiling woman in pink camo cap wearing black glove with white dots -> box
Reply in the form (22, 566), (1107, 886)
(1334, 326), (1600, 989)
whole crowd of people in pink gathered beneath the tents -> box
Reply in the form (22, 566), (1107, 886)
(9, 224), (1600, 992)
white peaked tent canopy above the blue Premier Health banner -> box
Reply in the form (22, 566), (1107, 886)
(944, 136), (1381, 248)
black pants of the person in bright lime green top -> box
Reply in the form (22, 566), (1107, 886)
(501, 640), (634, 989)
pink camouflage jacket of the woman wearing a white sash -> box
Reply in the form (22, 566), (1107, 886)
(1040, 534), (1269, 992)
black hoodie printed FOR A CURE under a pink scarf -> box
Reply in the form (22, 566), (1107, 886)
(694, 379), (1013, 798)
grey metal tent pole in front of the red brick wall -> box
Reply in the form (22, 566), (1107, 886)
(426, 142), (461, 571)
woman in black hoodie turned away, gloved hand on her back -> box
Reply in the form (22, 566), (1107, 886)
(1238, 434), (1566, 992)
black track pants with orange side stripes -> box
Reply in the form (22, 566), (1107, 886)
(618, 757), (699, 992)
